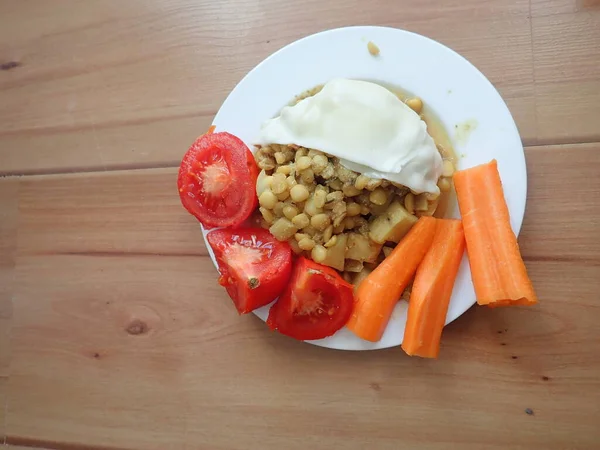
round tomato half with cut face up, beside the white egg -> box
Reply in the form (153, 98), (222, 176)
(177, 129), (259, 228)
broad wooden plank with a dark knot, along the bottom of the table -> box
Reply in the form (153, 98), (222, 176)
(8, 257), (600, 449)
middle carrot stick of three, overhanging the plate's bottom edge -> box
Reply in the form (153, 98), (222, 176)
(402, 219), (465, 358)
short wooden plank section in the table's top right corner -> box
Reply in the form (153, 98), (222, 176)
(531, 4), (600, 144)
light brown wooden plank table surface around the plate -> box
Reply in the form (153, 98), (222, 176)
(0, 0), (600, 450)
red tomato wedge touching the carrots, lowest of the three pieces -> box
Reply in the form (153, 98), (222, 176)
(267, 258), (354, 341)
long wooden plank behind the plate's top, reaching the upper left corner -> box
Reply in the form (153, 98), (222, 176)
(0, 0), (536, 173)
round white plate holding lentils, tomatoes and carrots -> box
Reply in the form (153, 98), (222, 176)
(203, 27), (527, 350)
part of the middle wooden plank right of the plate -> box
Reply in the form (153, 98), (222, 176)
(519, 144), (600, 262)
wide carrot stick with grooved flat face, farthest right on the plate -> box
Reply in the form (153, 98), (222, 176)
(454, 160), (537, 307)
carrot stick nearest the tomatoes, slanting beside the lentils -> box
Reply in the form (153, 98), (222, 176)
(346, 216), (436, 342)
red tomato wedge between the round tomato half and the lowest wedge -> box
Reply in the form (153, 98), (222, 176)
(206, 228), (292, 314)
